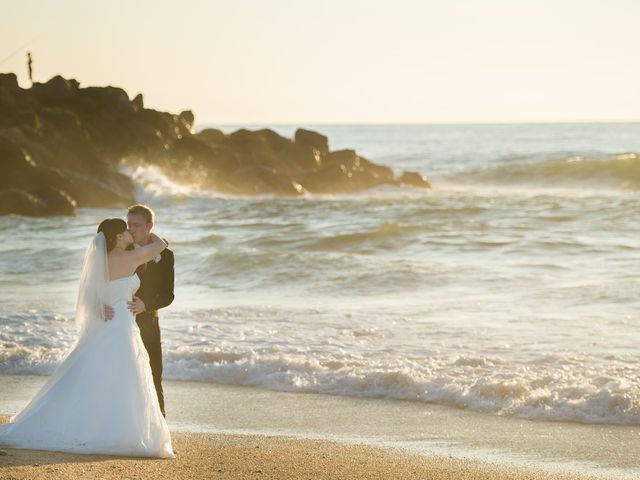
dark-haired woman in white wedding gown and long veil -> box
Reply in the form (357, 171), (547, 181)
(0, 218), (175, 458)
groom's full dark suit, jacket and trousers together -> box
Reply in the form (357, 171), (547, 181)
(135, 248), (174, 416)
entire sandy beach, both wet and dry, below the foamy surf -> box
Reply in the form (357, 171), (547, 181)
(5, 375), (640, 480)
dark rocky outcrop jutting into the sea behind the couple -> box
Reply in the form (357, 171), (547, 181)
(0, 73), (429, 216)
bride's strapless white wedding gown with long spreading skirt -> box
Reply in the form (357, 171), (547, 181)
(0, 274), (175, 458)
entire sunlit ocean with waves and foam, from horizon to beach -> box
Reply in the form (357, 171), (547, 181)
(0, 123), (640, 425)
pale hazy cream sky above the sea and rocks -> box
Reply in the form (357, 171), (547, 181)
(0, 0), (640, 124)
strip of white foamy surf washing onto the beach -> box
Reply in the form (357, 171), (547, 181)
(0, 320), (640, 425)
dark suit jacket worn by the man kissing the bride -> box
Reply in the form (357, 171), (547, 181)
(135, 248), (174, 320)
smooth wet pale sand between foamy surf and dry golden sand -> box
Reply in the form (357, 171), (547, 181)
(0, 375), (640, 480)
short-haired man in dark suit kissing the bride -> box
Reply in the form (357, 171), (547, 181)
(105, 205), (174, 417)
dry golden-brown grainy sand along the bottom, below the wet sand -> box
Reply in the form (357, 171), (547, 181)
(0, 417), (593, 480)
